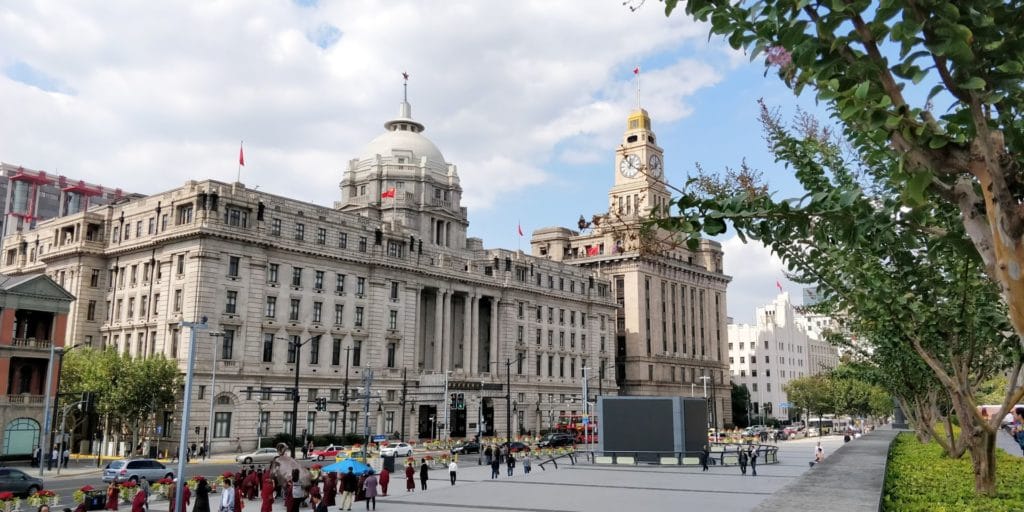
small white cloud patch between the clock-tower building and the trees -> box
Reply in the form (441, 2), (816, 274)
(722, 236), (804, 324)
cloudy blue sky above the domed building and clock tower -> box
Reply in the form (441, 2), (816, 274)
(0, 0), (813, 323)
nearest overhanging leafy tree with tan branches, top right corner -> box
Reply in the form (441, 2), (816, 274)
(666, 0), (1024, 344)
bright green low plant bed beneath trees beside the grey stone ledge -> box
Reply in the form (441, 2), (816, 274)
(883, 433), (1024, 512)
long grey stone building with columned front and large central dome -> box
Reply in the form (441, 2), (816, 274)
(0, 83), (615, 454)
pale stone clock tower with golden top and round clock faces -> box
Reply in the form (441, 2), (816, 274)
(608, 109), (670, 217)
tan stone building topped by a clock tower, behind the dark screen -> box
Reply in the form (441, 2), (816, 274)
(530, 110), (732, 428)
